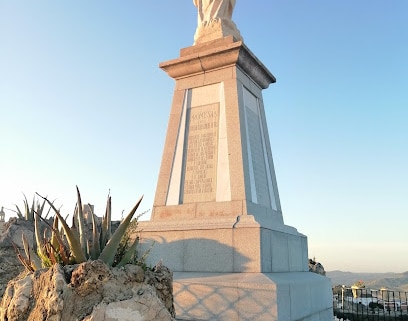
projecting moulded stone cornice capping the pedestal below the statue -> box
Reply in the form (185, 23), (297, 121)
(159, 36), (276, 89)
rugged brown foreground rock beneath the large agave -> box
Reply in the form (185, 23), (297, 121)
(0, 261), (175, 321)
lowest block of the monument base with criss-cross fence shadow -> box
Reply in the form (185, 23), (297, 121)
(173, 272), (333, 321)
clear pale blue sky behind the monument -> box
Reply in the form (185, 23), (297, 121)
(0, 0), (408, 272)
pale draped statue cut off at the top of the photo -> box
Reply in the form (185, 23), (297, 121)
(193, 0), (242, 44)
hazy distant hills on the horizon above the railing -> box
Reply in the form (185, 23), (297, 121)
(326, 271), (408, 292)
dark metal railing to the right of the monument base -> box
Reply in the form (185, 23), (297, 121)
(333, 287), (408, 321)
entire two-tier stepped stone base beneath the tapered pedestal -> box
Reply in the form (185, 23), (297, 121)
(138, 220), (333, 321)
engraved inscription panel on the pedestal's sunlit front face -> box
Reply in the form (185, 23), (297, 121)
(183, 103), (219, 203)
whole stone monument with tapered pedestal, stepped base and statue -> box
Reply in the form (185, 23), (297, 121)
(139, 0), (333, 321)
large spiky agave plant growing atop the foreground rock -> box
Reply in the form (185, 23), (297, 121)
(17, 186), (143, 271)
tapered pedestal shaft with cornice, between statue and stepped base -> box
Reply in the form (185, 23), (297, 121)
(152, 37), (283, 227)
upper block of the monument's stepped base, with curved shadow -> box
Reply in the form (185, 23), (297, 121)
(138, 215), (309, 273)
